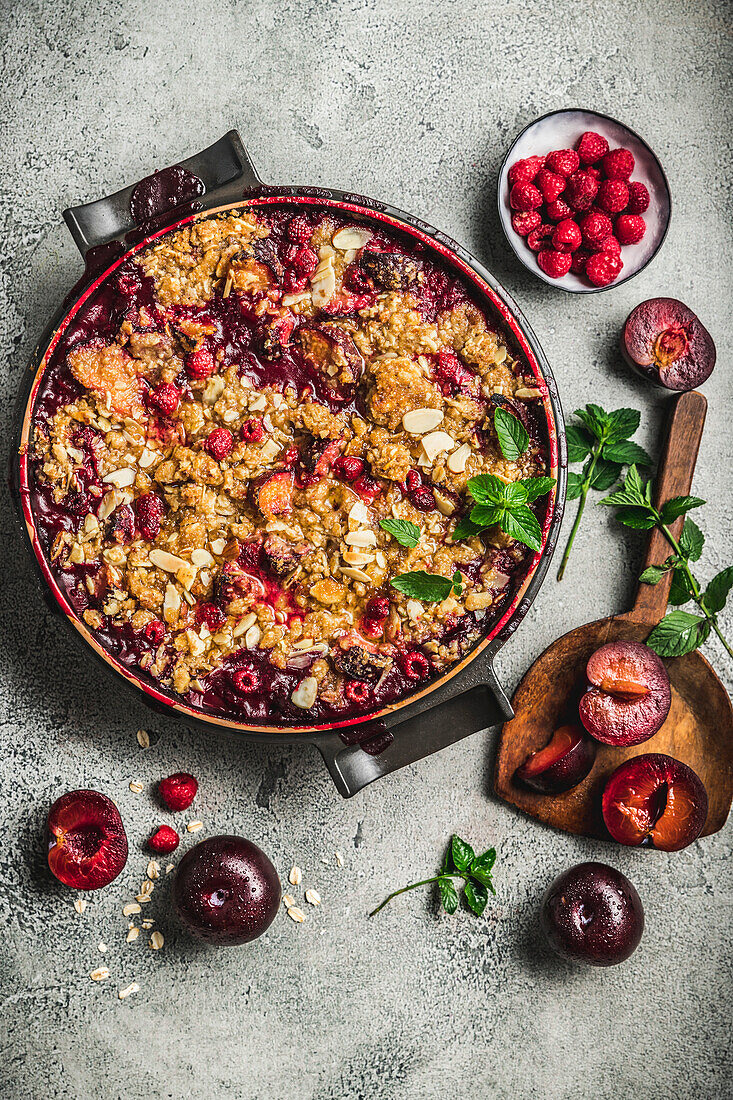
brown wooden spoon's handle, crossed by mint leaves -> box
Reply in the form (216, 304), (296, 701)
(632, 392), (708, 626)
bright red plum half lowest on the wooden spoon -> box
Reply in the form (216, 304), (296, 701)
(603, 752), (708, 851)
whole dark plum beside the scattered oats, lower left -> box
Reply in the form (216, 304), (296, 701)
(173, 836), (282, 947)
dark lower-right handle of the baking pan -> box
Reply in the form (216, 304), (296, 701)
(315, 668), (514, 799)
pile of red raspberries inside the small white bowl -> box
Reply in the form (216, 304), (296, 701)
(508, 130), (649, 287)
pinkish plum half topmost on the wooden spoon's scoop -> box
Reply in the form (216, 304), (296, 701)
(578, 641), (671, 745)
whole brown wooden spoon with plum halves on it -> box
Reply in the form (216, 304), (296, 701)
(494, 393), (733, 839)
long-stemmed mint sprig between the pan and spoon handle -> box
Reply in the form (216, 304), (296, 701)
(557, 405), (652, 581)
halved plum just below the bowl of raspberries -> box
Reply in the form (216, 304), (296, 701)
(621, 298), (715, 389)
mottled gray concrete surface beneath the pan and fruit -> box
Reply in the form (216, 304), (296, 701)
(0, 0), (733, 1100)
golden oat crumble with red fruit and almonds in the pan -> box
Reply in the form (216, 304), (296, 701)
(30, 204), (548, 725)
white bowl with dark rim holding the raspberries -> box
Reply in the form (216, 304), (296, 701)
(499, 109), (671, 294)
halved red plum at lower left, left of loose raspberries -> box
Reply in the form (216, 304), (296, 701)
(47, 791), (128, 890)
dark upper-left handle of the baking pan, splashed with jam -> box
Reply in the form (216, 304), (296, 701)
(64, 130), (262, 256)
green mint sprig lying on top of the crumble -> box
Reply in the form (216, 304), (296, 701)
(452, 474), (555, 550)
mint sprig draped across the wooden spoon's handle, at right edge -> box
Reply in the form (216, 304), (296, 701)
(601, 465), (733, 657)
